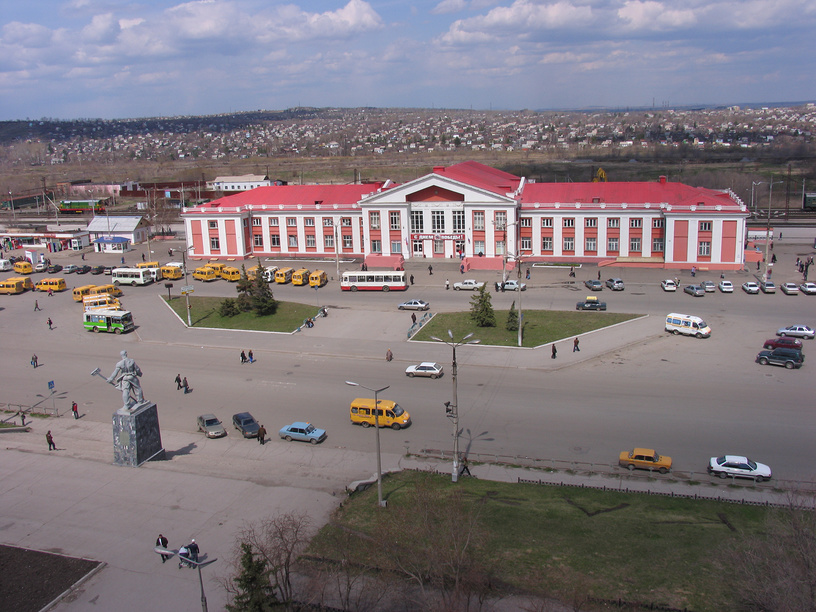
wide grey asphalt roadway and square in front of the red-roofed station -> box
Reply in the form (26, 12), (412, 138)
(0, 244), (816, 486)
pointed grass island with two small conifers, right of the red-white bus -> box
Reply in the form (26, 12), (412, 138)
(413, 310), (642, 347)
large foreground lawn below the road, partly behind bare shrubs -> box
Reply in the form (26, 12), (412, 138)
(309, 472), (769, 612)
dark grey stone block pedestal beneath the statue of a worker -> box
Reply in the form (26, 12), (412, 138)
(113, 402), (164, 467)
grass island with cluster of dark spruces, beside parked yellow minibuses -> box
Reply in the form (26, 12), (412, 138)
(164, 296), (317, 333)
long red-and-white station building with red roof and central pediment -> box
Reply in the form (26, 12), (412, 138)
(182, 162), (748, 270)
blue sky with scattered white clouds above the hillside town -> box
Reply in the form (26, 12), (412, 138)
(0, 0), (816, 120)
